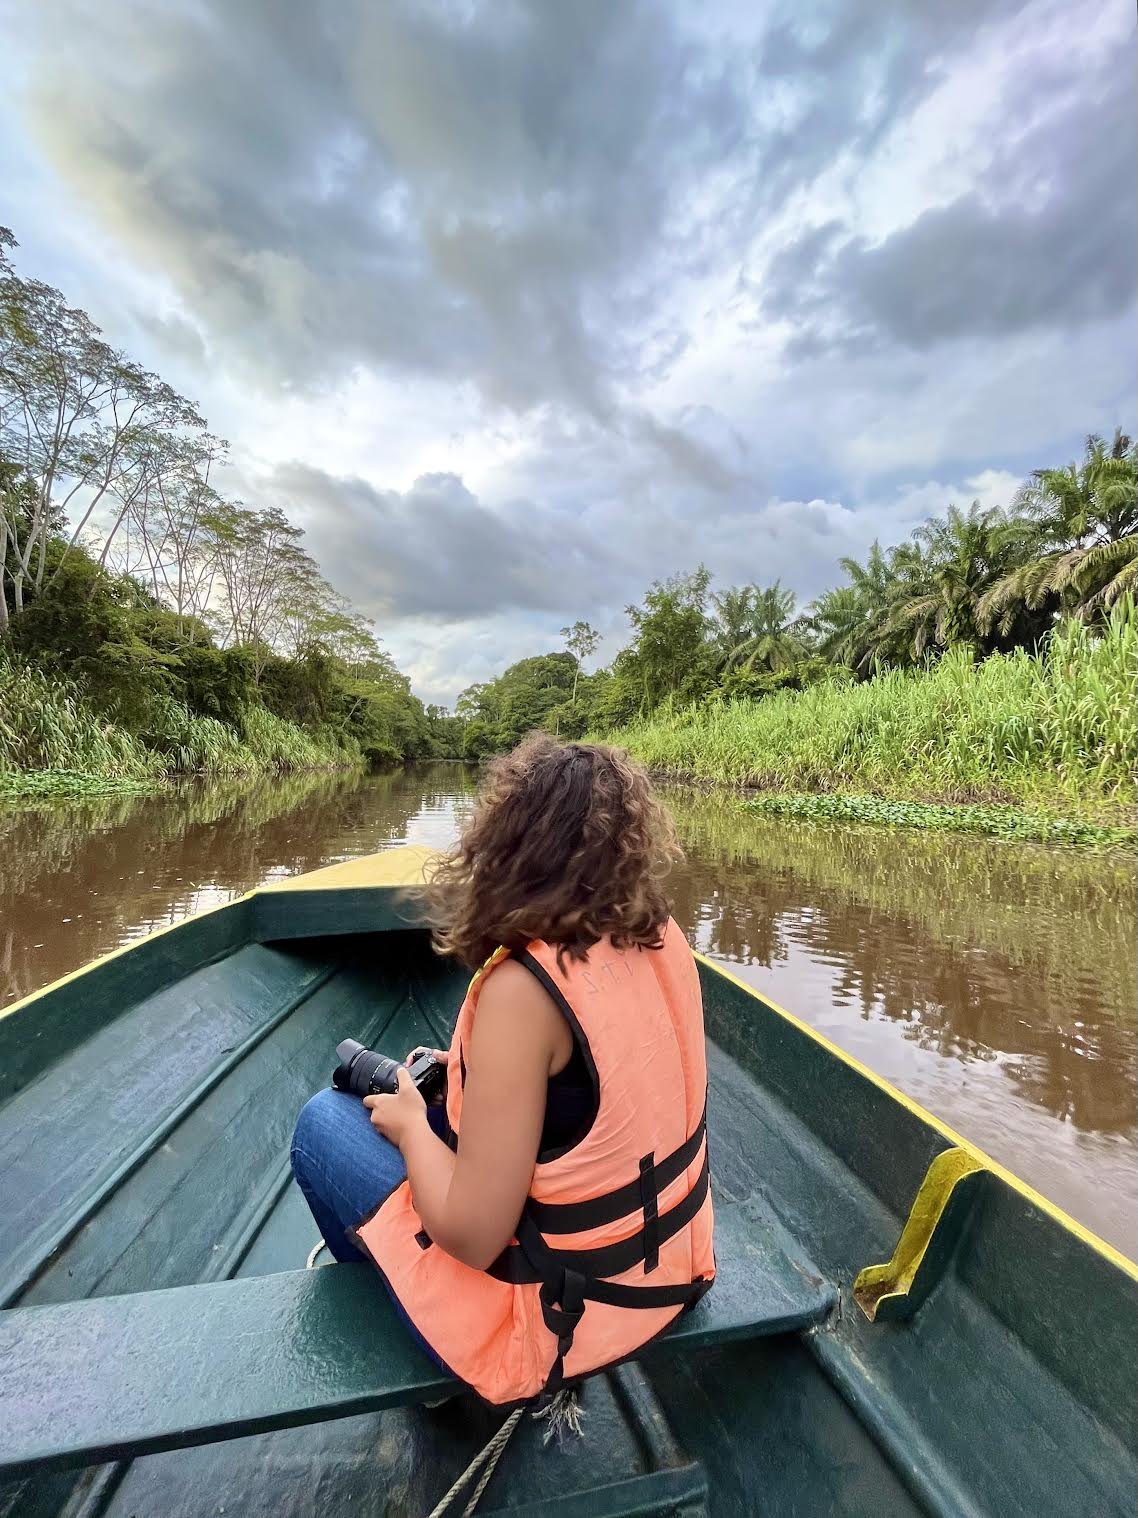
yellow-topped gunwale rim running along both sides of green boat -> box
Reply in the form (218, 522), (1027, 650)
(0, 844), (1138, 1281)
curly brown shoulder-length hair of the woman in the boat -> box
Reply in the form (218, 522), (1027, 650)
(426, 733), (683, 968)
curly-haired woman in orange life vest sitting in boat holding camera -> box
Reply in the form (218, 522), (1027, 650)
(293, 736), (715, 1404)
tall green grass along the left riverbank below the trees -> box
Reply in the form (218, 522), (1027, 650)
(0, 653), (360, 798)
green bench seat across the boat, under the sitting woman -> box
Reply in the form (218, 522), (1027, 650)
(0, 1202), (836, 1474)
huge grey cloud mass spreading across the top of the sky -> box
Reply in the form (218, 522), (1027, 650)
(20, 0), (1049, 415)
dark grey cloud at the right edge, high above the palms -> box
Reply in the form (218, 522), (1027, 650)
(765, 35), (1138, 357)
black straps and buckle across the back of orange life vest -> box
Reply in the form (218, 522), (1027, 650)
(489, 1113), (712, 1392)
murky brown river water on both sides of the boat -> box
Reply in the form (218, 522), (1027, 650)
(0, 764), (1138, 1255)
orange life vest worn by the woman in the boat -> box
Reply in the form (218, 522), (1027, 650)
(352, 921), (715, 1404)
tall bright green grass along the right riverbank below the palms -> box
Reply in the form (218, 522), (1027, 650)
(607, 606), (1138, 809)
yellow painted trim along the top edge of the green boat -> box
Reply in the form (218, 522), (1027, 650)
(0, 844), (1138, 1280)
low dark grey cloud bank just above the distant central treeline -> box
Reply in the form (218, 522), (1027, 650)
(265, 434), (942, 634)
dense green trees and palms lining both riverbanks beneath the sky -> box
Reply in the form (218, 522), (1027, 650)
(0, 229), (1138, 794)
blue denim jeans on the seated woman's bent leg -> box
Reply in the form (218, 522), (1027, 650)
(291, 1087), (442, 1365)
